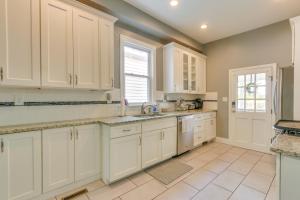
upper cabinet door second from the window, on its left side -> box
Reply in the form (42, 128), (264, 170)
(73, 9), (100, 89)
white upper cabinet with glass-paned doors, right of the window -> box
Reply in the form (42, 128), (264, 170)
(164, 43), (206, 94)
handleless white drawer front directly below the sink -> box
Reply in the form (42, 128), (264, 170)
(142, 117), (177, 132)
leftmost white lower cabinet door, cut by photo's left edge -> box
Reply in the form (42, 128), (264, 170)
(0, 131), (42, 200)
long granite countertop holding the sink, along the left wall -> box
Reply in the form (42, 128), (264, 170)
(0, 110), (216, 135)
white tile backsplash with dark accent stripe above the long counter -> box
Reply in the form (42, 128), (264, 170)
(0, 89), (217, 126)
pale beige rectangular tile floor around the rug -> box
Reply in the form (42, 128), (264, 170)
(55, 142), (275, 200)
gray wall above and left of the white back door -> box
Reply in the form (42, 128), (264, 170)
(204, 20), (292, 138)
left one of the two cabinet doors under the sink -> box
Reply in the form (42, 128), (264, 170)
(142, 130), (162, 168)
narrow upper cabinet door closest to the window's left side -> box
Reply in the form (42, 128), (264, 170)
(99, 18), (114, 90)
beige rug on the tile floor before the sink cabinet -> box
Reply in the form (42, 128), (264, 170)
(146, 160), (193, 185)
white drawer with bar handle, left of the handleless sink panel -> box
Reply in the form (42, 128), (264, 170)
(110, 123), (141, 138)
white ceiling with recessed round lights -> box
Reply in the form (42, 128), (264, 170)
(124, 0), (300, 43)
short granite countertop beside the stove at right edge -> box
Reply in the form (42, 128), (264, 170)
(271, 134), (300, 157)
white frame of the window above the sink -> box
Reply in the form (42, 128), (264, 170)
(120, 34), (156, 106)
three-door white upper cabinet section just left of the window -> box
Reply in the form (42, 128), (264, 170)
(41, 0), (116, 90)
